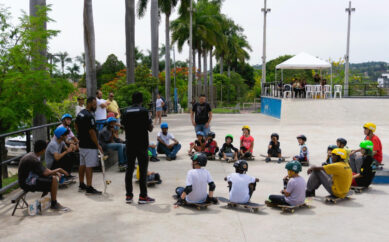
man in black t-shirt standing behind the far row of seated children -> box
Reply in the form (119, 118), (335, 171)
(190, 94), (212, 137)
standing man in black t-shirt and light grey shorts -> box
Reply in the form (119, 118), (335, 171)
(75, 97), (103, 195)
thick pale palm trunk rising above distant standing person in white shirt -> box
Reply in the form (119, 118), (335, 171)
(150, 0), (159, 114)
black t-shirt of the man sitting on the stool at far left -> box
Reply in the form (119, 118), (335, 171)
(18, 152), (46, 189)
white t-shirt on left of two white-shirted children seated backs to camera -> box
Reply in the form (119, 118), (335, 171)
(185, 168), (213, 203)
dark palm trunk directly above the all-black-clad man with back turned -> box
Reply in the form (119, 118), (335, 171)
(125, 0), (135, 83)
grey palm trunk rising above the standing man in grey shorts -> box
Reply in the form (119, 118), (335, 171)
(84, 0), (97, 97)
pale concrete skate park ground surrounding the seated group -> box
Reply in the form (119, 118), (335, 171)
(0, 99), (389, 241)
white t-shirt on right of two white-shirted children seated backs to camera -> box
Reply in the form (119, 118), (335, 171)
(227, 173), (255, 203)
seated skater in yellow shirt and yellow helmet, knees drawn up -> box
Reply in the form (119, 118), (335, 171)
(306, 148), (353, 198)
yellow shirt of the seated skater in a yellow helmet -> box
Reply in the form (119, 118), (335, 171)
(323, 162), (353, 198)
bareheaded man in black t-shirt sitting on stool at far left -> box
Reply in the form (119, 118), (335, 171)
(18, 140), (69, 210)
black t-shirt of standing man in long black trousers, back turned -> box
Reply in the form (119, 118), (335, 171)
(121, 106), (153, 149)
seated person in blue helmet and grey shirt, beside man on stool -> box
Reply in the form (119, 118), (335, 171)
(45, 127), (76, 180)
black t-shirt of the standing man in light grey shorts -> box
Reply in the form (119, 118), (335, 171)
(76, 109), (98, 149)
